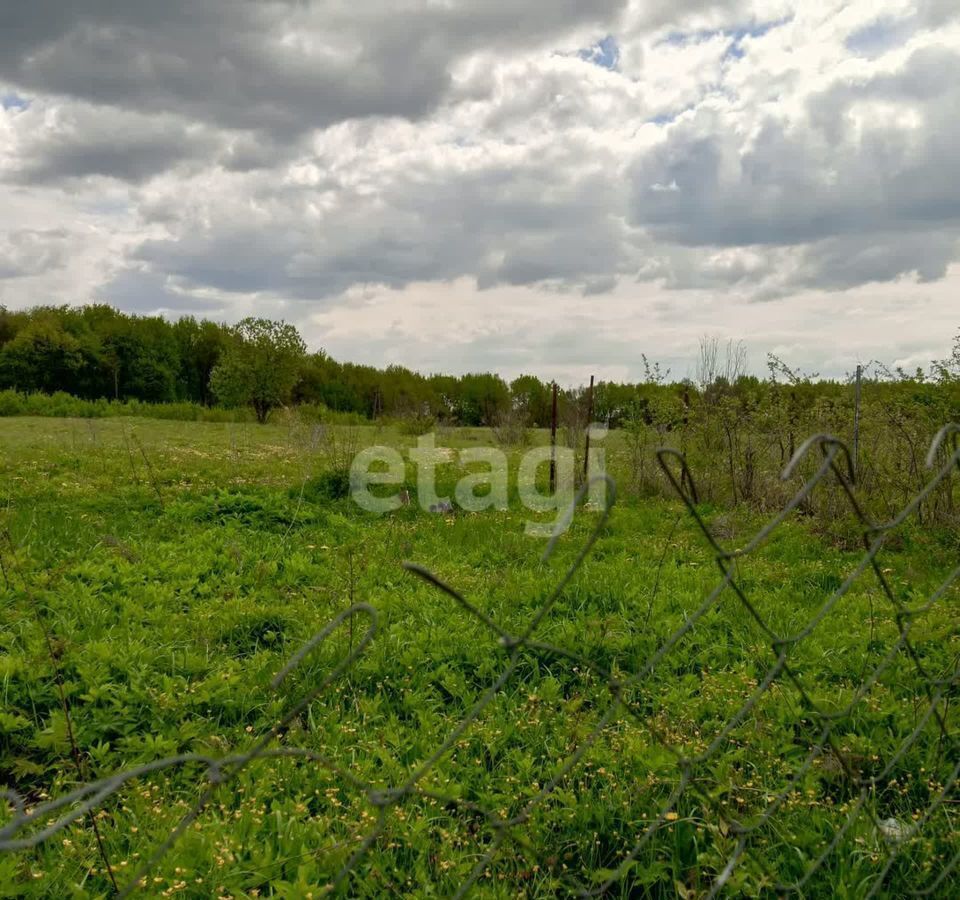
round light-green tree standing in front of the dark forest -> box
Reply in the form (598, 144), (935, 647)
(210, 318), (307, 424)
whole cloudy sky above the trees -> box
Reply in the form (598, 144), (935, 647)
(0, 0), (960, 383)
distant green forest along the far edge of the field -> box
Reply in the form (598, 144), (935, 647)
(0, 305), (960, 426)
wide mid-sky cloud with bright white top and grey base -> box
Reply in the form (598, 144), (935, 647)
(129, 111), (629, 299)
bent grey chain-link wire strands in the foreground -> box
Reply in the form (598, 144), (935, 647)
(0, 425), (960, 897)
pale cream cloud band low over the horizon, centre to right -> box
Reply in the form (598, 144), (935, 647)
(294, 266), (960, 385)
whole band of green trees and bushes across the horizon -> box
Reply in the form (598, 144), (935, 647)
(0, 306), (960, 442)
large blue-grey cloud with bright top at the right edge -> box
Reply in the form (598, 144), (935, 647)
(631, 42), (960, 287)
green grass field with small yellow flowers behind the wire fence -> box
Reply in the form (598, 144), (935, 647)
(0, 418), (960, 898)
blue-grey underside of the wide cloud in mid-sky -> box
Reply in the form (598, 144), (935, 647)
(131, 134), (624, 298)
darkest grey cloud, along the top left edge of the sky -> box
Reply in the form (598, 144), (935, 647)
(0, 0), (625, 135)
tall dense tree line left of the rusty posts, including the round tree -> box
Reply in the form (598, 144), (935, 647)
(0, 305), (516, 425)
